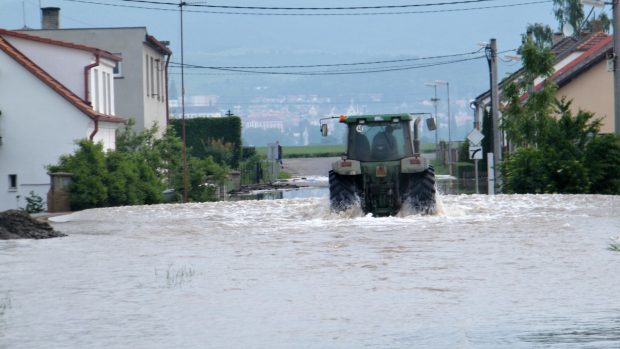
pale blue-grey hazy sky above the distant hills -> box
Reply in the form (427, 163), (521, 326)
(0, 0), (555, 64)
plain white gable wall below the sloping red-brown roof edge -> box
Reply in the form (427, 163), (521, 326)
(0, 48), (100, 211)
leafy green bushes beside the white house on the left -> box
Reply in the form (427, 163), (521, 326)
(48, 122), (228, 210)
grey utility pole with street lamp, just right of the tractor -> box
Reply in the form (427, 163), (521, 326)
(485, 39), (502, 192)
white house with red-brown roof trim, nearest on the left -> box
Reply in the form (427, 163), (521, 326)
(0, 29), (125, 211)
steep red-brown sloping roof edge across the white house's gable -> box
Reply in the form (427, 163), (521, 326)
(0, 33), (126, 123)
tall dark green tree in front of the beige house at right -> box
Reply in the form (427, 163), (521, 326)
(501, 34), (620, 194)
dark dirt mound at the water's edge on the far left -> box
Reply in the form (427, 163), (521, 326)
(0, 210), (66, 240)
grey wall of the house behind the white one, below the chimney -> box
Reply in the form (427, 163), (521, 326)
(23, 27), (166, 133)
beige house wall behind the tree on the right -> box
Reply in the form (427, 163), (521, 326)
(556, 60), (614, 133)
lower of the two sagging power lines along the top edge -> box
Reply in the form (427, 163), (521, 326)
(63, 0), (552, 16)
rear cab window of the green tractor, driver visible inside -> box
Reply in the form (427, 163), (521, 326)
(348, 122), (412, 161)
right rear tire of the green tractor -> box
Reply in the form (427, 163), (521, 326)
(407, 166), (437, 214)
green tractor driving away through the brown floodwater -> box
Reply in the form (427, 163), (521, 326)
(321, 113), (436, 217)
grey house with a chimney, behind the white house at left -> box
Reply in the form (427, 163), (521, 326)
(20, 7), (172, 135)
